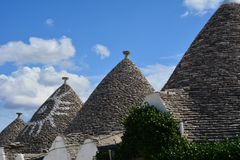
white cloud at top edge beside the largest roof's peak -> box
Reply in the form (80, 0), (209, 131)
(183, 0), (222, 15)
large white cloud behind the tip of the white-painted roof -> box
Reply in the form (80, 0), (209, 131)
(0, 67), (92, 109)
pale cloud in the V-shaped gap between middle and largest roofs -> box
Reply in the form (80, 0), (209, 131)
(142, 64), (175, 91)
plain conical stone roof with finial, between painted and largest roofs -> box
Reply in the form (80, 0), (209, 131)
(66, 52), (153, 135)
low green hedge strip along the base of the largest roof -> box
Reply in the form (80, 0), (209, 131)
(153, 137), (240, 160)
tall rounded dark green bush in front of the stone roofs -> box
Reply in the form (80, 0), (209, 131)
(114, 104), (186, 160)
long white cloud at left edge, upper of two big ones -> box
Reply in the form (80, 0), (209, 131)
(0, 36), (75, 65)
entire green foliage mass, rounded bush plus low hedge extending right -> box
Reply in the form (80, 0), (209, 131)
(115, 104), (240, 160)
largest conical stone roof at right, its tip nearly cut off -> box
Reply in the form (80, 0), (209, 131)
(161, 3), (240, 141)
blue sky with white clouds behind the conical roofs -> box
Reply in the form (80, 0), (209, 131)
(0, 0), (225, 130)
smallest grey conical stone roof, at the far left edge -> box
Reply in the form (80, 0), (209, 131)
(0, 113), (26, 147)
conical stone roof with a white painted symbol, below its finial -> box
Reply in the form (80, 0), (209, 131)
(17, 83), (82, 153)
